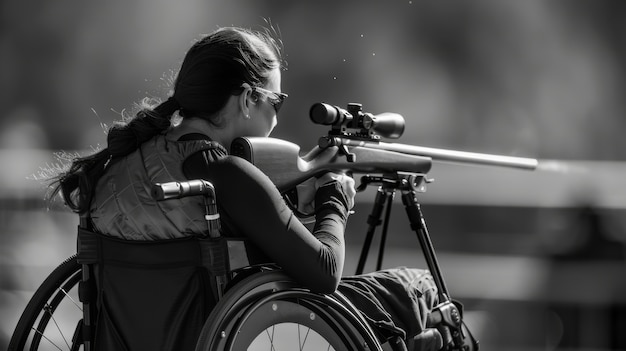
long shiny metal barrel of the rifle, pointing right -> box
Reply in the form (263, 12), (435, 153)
(334, 137), (539, 170)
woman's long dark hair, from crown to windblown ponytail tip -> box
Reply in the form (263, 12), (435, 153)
(50, 27), (284, 214)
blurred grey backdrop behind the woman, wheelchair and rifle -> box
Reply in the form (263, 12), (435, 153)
(0, 0), (626, 350)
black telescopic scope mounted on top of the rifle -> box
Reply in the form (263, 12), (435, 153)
(309, 102), (404, 139)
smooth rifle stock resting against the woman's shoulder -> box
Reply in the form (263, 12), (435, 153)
(231, 137), (431, 193)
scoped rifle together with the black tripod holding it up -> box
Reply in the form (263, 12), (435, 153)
(231, 103), (538, 351)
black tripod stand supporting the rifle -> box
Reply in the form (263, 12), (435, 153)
(356, 172), (478, 351)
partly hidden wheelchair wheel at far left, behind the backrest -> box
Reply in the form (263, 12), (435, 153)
(9, 255), (83, 351)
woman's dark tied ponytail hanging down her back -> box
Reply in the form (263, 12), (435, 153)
(50, 97), (180, 214)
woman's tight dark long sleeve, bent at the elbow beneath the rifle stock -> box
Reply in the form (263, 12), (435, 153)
(179, 134), (347, 293)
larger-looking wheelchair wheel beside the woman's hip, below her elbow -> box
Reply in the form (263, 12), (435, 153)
(196, 271), (381, 351)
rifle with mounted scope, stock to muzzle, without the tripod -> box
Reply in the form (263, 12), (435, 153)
(231, 103), (538, 194)
